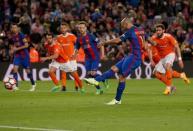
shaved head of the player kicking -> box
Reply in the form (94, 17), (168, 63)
(121, 16), (133, 30)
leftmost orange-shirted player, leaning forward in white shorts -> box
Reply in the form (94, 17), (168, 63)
(40, 33), (85, 93)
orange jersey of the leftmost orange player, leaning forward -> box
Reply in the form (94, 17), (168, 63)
(45, 42), (69, 63)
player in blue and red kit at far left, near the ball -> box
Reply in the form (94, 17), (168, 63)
(11, 24), (36, 91)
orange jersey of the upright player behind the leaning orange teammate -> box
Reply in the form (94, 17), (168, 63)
(56, 33), (76, 58)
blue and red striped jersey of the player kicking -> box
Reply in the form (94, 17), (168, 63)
(120, 26), (145, 59)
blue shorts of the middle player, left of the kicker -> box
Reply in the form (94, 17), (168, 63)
(85, 60), (99, 71)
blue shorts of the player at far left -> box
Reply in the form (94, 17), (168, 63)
(13, 56), (30, 69)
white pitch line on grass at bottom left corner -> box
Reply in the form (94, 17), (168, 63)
(0, 125), (70, 131)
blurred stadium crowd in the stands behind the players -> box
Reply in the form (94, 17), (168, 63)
(0, 0), (193, 61)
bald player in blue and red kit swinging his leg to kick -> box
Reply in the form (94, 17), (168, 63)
(85, 16), (144, 105)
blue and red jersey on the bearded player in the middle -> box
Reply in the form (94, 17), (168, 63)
(75, 33), (100, 60)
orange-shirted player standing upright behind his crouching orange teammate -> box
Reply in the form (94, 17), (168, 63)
(56, 22), (82, 91)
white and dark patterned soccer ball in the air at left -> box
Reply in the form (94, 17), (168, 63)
(3, 77), (17, 90)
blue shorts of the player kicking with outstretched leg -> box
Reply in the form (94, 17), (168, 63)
(115, 54), (142, 77)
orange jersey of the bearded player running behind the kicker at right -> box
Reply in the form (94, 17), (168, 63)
(152, 33), (177, 58)
